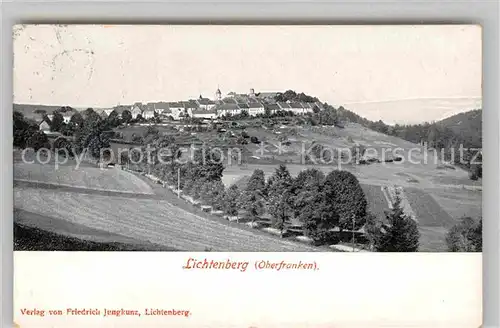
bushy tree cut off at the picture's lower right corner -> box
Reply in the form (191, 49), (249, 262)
(446, 217), (483, 252)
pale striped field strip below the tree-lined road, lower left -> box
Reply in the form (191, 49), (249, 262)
(14, 187), (317, 251)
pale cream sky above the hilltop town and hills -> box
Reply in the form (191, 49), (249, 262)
(10, 25), (482, 123)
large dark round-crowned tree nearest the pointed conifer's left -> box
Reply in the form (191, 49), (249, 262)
(324, 170), (368, 230)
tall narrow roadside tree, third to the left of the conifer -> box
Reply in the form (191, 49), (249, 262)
(266, 165), (293, 234)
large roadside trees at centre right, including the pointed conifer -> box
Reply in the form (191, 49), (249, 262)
(236, 165), (420, 252)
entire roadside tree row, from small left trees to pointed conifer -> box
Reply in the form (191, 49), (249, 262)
(148, 161), (419, 252)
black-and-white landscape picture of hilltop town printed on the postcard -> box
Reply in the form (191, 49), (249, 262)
(12, 24), (483, 252)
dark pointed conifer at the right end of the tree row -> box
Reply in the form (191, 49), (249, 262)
(373, 194), (420, 252)
